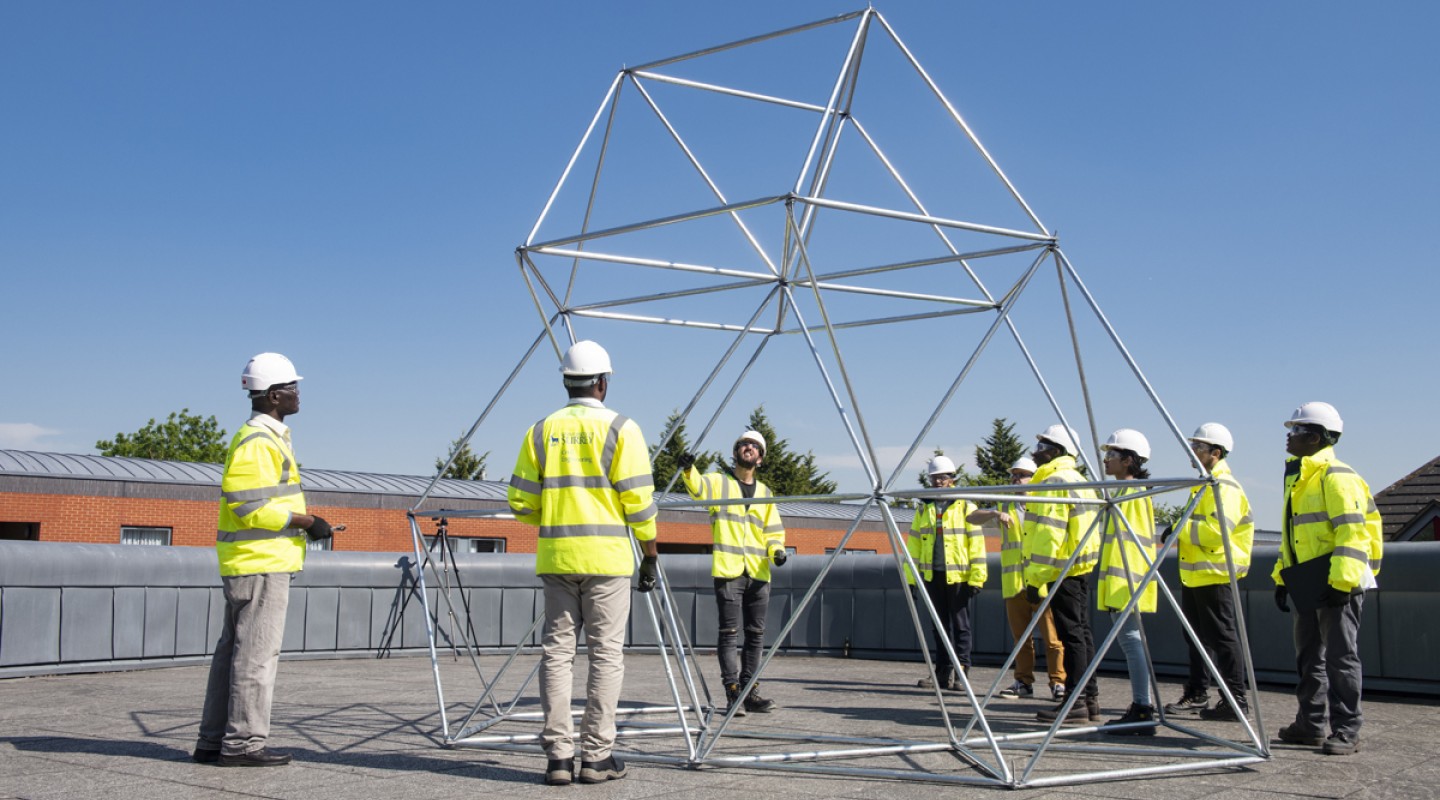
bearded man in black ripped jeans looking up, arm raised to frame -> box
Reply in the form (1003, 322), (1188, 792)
(681, 430), (788, 717)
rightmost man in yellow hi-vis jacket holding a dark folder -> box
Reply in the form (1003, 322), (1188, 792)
(1272, 403), (1384, 755)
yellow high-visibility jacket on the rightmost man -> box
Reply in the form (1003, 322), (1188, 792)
(1272, 447), (1384, 591)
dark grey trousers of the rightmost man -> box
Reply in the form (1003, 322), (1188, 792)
(1295, 594), (1365, 737)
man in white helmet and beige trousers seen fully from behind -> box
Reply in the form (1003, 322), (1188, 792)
(507, 341), (658, 786)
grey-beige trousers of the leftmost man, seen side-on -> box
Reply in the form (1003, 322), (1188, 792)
(196, 573), (291, 755)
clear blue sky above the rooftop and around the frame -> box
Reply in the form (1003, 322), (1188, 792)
(0, 1), (1440, 528)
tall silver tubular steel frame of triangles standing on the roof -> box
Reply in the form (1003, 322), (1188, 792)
(409, 7), (1270, 788)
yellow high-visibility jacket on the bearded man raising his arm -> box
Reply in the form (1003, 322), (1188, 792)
(683, 466), (785, 583)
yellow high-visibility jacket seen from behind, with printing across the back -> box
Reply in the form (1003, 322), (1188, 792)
(505, 400), (660, 576)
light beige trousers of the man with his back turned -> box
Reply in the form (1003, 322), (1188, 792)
(540, 576), (631, 761)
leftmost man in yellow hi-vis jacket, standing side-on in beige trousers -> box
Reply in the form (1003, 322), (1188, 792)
(192, 353), (335, 767)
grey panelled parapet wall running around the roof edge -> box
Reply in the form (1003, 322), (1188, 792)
(0, 542), (1440, 695)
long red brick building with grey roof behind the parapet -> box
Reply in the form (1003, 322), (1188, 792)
(0, 450), (921, 555)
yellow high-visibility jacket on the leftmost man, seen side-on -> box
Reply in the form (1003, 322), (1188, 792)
(215, 413), (305, 576)
